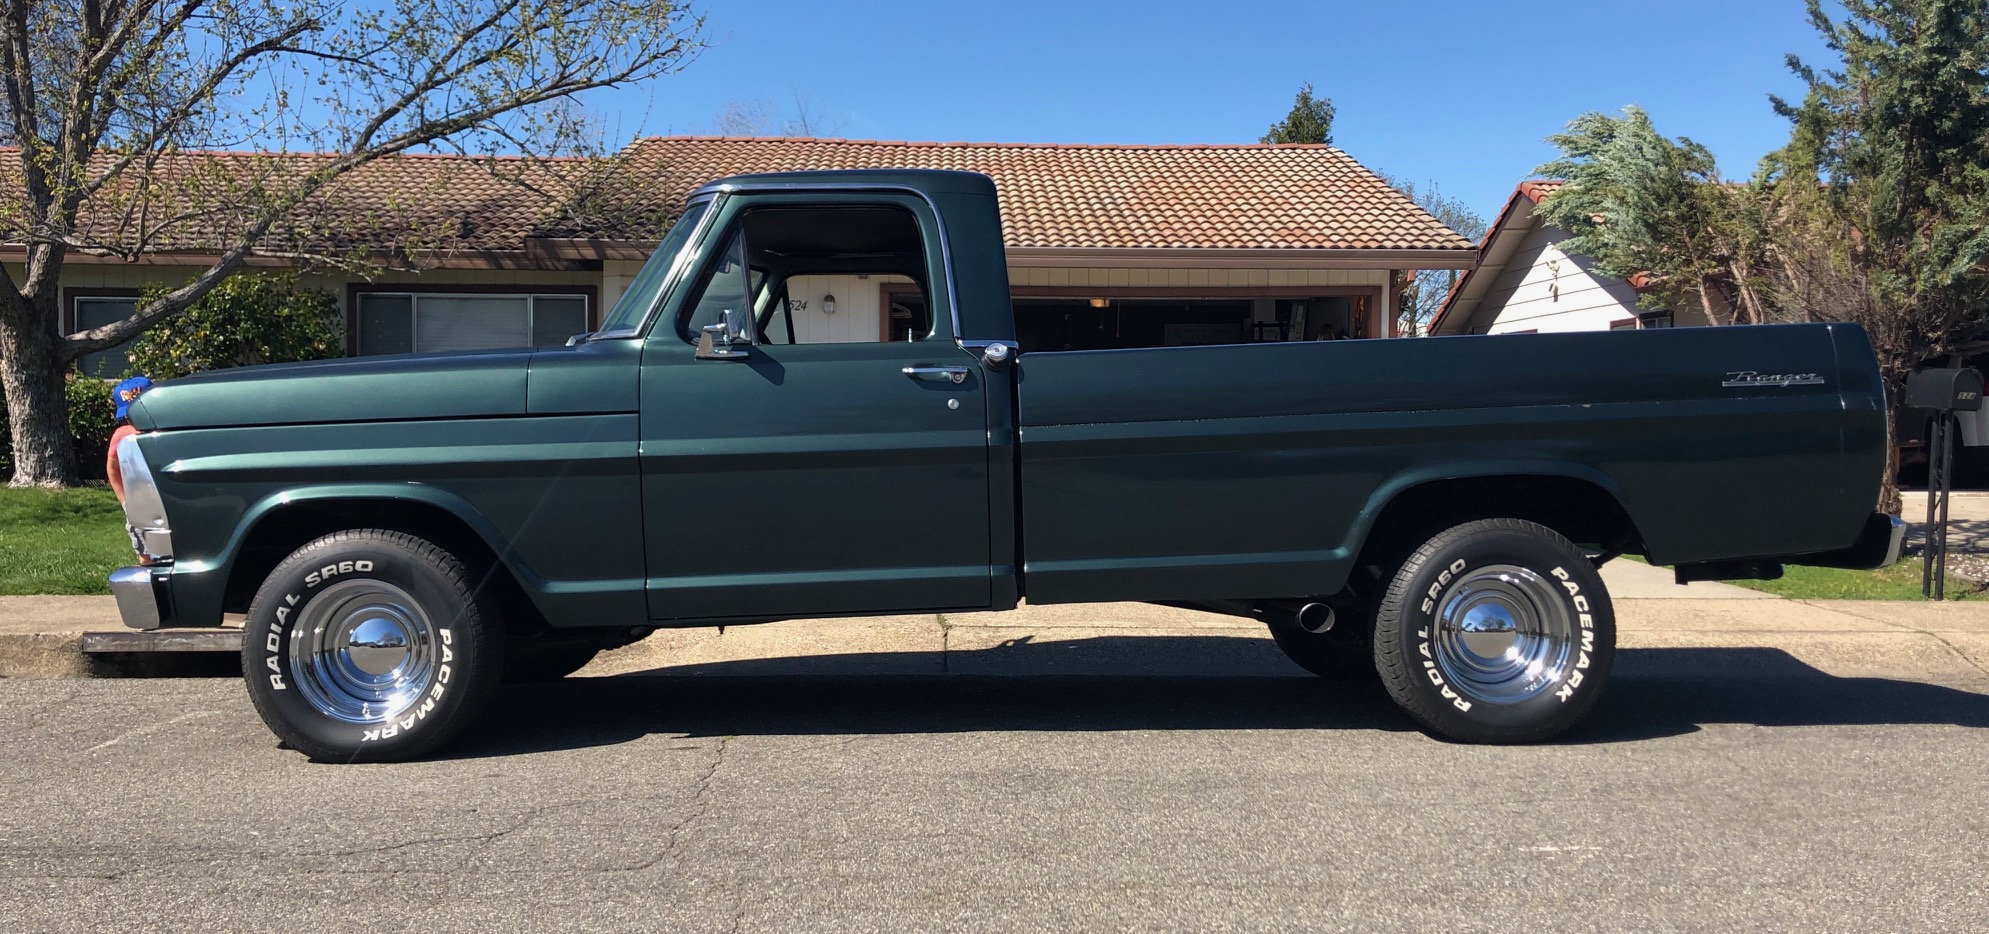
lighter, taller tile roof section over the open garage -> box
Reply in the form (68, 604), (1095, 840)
(627, 137), (1474, 250)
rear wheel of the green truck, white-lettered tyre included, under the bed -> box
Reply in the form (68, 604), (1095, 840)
(1374, 519), (1615, 743)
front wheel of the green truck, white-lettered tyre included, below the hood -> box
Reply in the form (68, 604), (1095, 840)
(243, 529), (503, 761)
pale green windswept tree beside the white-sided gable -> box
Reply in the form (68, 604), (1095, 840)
(1534, 105), (1762, 324)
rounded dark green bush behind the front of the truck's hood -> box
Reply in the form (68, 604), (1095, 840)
(129, 272), (346, 380)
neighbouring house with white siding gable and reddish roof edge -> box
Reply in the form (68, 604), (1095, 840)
(1430, 181), (1709, 336)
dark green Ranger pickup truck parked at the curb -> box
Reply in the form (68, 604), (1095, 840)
(111, 171), (1901, 761)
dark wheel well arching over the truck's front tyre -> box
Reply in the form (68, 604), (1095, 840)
(223, 499), (545, 632)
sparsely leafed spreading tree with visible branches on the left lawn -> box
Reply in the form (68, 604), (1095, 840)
(0, 0), (704, 485)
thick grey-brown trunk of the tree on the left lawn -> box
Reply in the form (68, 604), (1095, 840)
(0, 288), (76, 487)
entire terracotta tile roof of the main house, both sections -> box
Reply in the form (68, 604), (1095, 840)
(0, 137), (1474, 254)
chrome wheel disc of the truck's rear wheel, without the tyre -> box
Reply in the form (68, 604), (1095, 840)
(1432, 564), (1579, 703)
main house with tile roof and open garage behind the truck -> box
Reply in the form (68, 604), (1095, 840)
(11, 137), (1480, 374)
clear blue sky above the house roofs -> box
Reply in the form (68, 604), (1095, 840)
(589, 0), (1826, 224)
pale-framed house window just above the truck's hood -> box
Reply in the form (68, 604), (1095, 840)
(354, 292), (587, 354)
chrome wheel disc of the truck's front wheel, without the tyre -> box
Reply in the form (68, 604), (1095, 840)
(290, 578), (442, 723)
